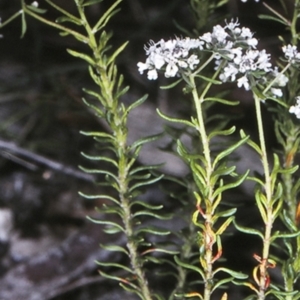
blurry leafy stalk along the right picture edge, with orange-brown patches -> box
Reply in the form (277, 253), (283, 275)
(258, 0), (300, 300)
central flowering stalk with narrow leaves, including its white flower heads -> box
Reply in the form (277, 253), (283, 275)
(138, 21), (258, 300)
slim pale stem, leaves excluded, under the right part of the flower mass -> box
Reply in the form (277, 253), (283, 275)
(254, 94), (274, 300)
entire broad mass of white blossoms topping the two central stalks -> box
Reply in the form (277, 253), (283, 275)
(138, 21), (291, 97)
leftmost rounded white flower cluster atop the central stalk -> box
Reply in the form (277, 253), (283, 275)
(138, 38), (203, 80)
